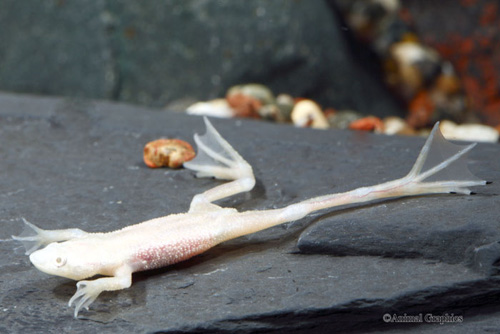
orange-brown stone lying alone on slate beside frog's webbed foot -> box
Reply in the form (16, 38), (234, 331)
(143, 138), (196, 168)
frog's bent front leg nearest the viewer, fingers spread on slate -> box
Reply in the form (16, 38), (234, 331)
(68, 265), (132, 318)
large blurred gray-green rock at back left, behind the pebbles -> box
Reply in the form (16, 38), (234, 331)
(0, 0), (401, 116)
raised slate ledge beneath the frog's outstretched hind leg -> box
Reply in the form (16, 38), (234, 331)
(298, 133), (500, 274)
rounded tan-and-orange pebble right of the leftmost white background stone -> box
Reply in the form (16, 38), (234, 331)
(226, 84), (274, 118)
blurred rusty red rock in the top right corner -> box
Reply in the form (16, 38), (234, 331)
(402, 0), (500, 127)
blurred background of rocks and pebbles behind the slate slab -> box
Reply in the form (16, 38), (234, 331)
(0, 0), (500, 141)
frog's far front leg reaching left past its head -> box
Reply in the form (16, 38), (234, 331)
(12, 218), (88, 255)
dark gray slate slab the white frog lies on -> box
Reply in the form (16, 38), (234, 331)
(0, 94), (500, 333)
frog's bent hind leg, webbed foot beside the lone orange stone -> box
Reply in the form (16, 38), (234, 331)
(184, 117), (255, 212)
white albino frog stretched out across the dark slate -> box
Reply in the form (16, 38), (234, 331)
(13, 118), (487, 317)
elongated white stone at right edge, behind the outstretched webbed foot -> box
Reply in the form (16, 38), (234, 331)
(441, 120), (499, 143)
